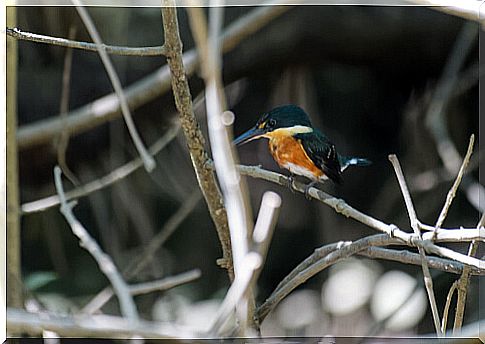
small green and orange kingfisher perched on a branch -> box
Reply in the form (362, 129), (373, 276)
(234, 105), (371, 192)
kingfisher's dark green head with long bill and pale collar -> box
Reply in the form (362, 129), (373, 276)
(234, 105), (313, 145)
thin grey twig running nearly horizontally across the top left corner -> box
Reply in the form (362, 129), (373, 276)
(6, 28), (165, 56)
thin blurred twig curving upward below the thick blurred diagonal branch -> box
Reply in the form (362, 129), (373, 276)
(21, 121), (180, 214)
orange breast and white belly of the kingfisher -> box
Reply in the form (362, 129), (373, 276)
(269, 135), (323, 179)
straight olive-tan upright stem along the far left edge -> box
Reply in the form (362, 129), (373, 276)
(6, 7), (23, 308)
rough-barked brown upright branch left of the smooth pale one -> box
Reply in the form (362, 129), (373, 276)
(162, 0), (234, 281)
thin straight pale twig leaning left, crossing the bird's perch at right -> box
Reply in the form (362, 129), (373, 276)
(389, 154), (443, 336)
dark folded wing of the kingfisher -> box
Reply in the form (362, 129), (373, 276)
(295, 131), (343, 184)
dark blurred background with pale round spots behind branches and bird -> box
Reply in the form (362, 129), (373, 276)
(12, 6), (483, 335)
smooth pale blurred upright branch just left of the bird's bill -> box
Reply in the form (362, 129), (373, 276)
(188, 3), (255, 335)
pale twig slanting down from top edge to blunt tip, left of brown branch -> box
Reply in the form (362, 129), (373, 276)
(72, 0), (156, 172)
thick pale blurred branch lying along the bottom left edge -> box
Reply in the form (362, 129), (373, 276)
(7, 308), (197, 339)
